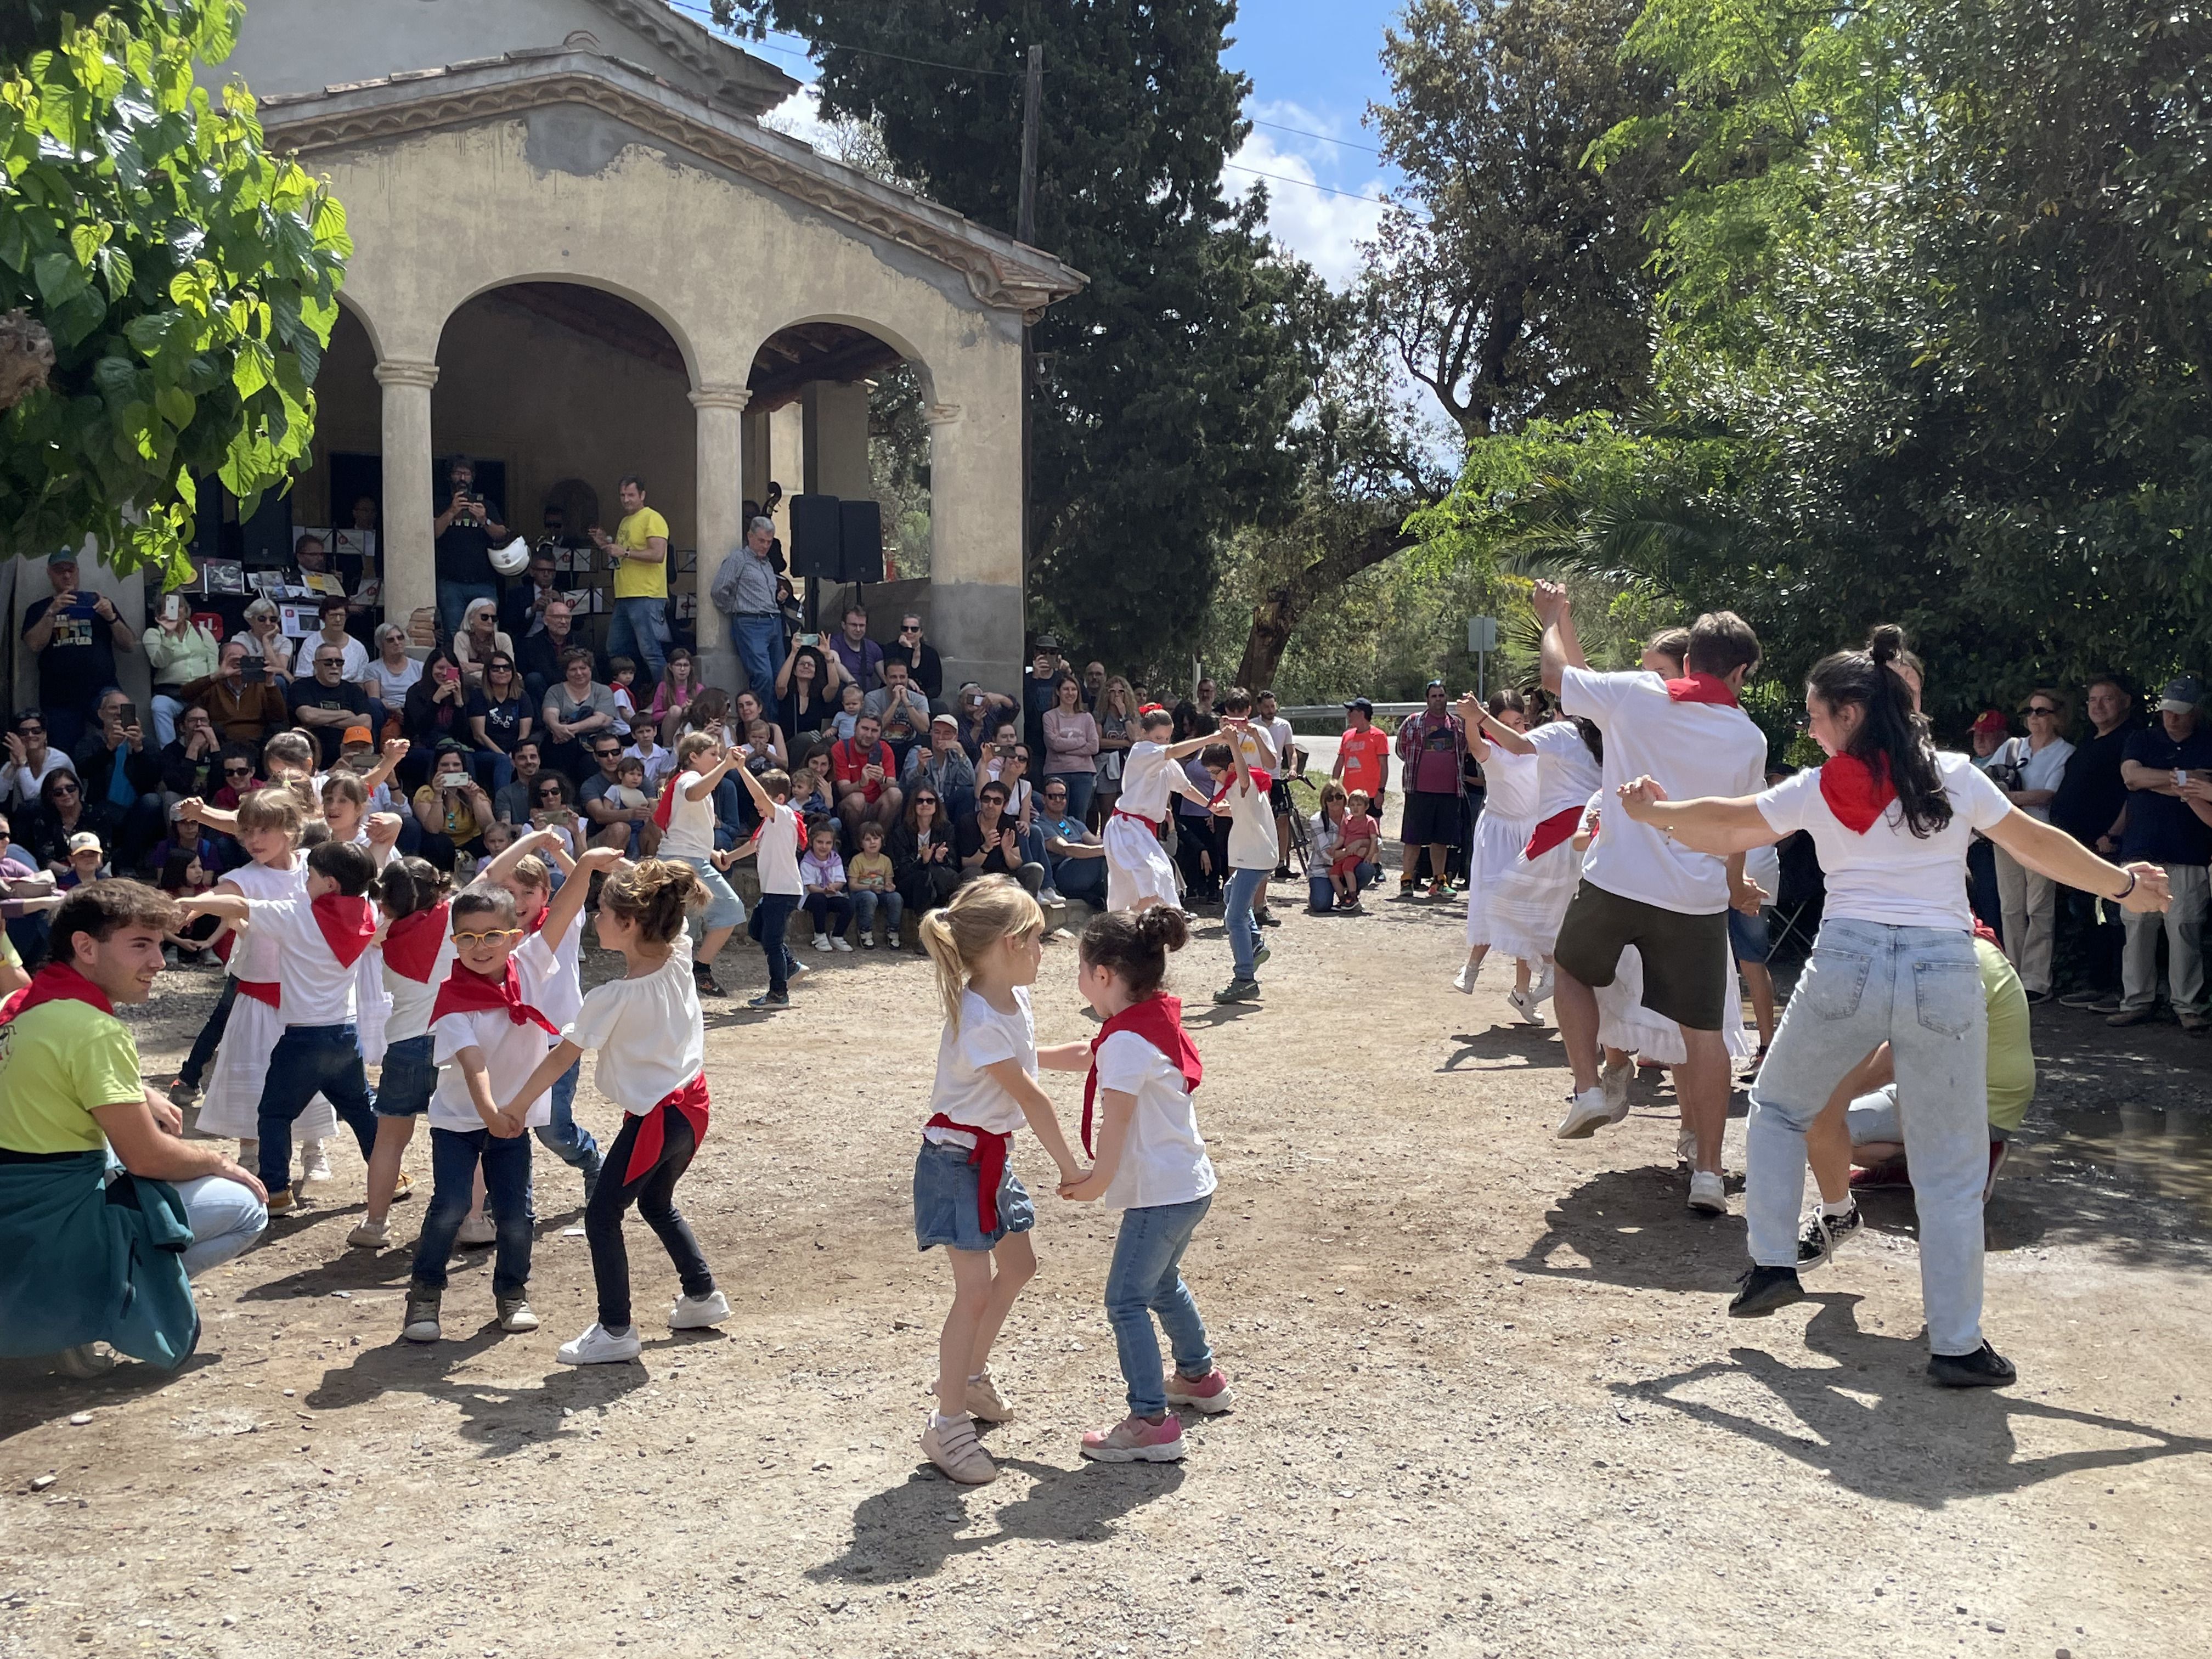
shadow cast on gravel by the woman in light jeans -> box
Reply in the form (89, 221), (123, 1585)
(1612, 1296), (2212, 1509)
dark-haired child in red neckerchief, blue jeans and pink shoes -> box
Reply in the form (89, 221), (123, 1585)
(1059, 909), (1232, 1462)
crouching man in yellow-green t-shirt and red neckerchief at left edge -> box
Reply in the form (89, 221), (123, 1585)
(0, 881), (268, 1376)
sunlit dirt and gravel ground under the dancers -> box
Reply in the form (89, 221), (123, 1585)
(0, 887), (2212, 1659)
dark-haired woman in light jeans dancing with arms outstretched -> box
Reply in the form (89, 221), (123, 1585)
(1621, 626), (2168, 1387)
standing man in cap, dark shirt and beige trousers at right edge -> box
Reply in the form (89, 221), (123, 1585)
(2106, 675), (2212, 1033)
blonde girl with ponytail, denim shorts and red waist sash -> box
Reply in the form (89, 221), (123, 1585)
(913, 876), (1088, 1487)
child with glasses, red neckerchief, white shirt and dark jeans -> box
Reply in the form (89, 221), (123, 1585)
(400, 881), (562, 1342)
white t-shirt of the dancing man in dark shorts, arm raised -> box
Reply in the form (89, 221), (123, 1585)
(1560, 668), (1768, 916)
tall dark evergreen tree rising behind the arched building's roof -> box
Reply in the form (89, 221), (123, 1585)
(716, 0), (1325, 662)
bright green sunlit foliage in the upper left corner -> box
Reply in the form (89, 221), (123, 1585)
(0, 0), (352, 573)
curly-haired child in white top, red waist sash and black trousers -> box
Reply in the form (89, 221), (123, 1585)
(493, 858), (730, 1365)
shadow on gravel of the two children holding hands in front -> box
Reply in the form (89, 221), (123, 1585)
(808, 1458), (1183, 1584)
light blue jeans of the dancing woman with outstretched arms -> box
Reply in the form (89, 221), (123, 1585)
(1743, 920), (1989, 1354)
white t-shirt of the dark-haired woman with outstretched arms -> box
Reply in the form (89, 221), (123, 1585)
(1752, 754), (2013, 931)
